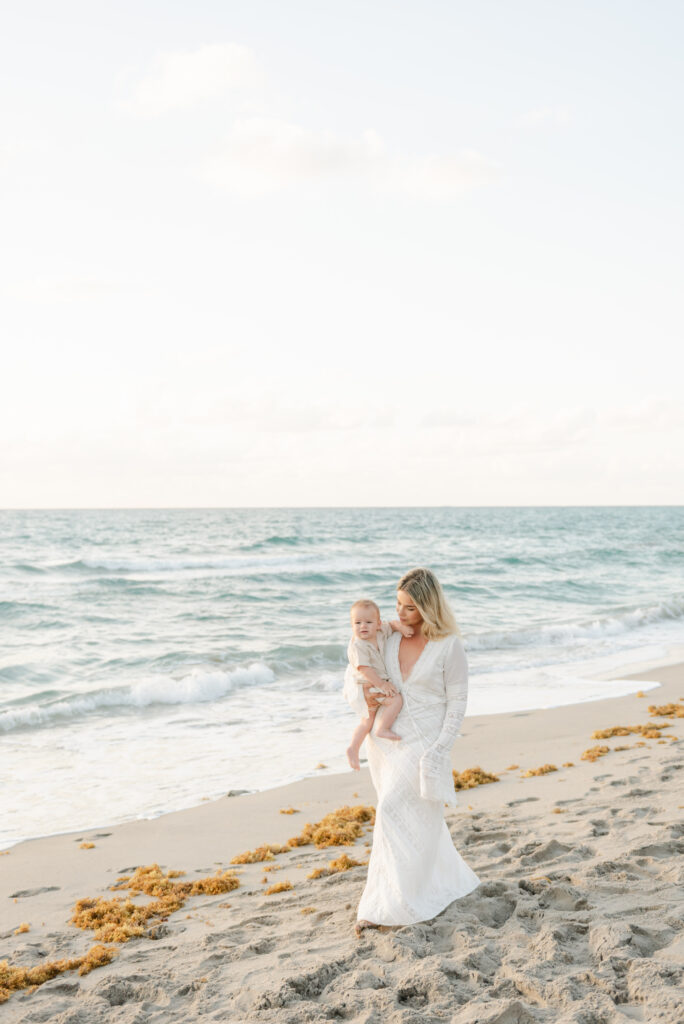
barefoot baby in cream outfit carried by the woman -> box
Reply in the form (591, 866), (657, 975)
(347, 601), (414, 771)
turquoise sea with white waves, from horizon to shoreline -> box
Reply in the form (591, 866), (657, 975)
(0, 508), (684, 845)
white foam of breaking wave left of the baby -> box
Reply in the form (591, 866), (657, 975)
(0, 662), (275, 732)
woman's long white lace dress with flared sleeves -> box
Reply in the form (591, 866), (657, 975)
(346, 633), (479, 925)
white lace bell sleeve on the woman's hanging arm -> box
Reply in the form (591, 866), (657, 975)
(420, 636), (468, 803)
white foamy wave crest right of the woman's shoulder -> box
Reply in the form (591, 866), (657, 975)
(465, 598), (684, 651)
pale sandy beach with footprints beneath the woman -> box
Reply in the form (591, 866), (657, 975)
(0, 665), (684, 1024)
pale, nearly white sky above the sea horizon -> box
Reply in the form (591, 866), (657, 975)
(0, 0), (684, 508)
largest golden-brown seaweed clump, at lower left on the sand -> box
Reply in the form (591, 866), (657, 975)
(71, 864), (240, 942)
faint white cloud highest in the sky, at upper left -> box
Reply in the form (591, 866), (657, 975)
(117, 43), (264, 118)
